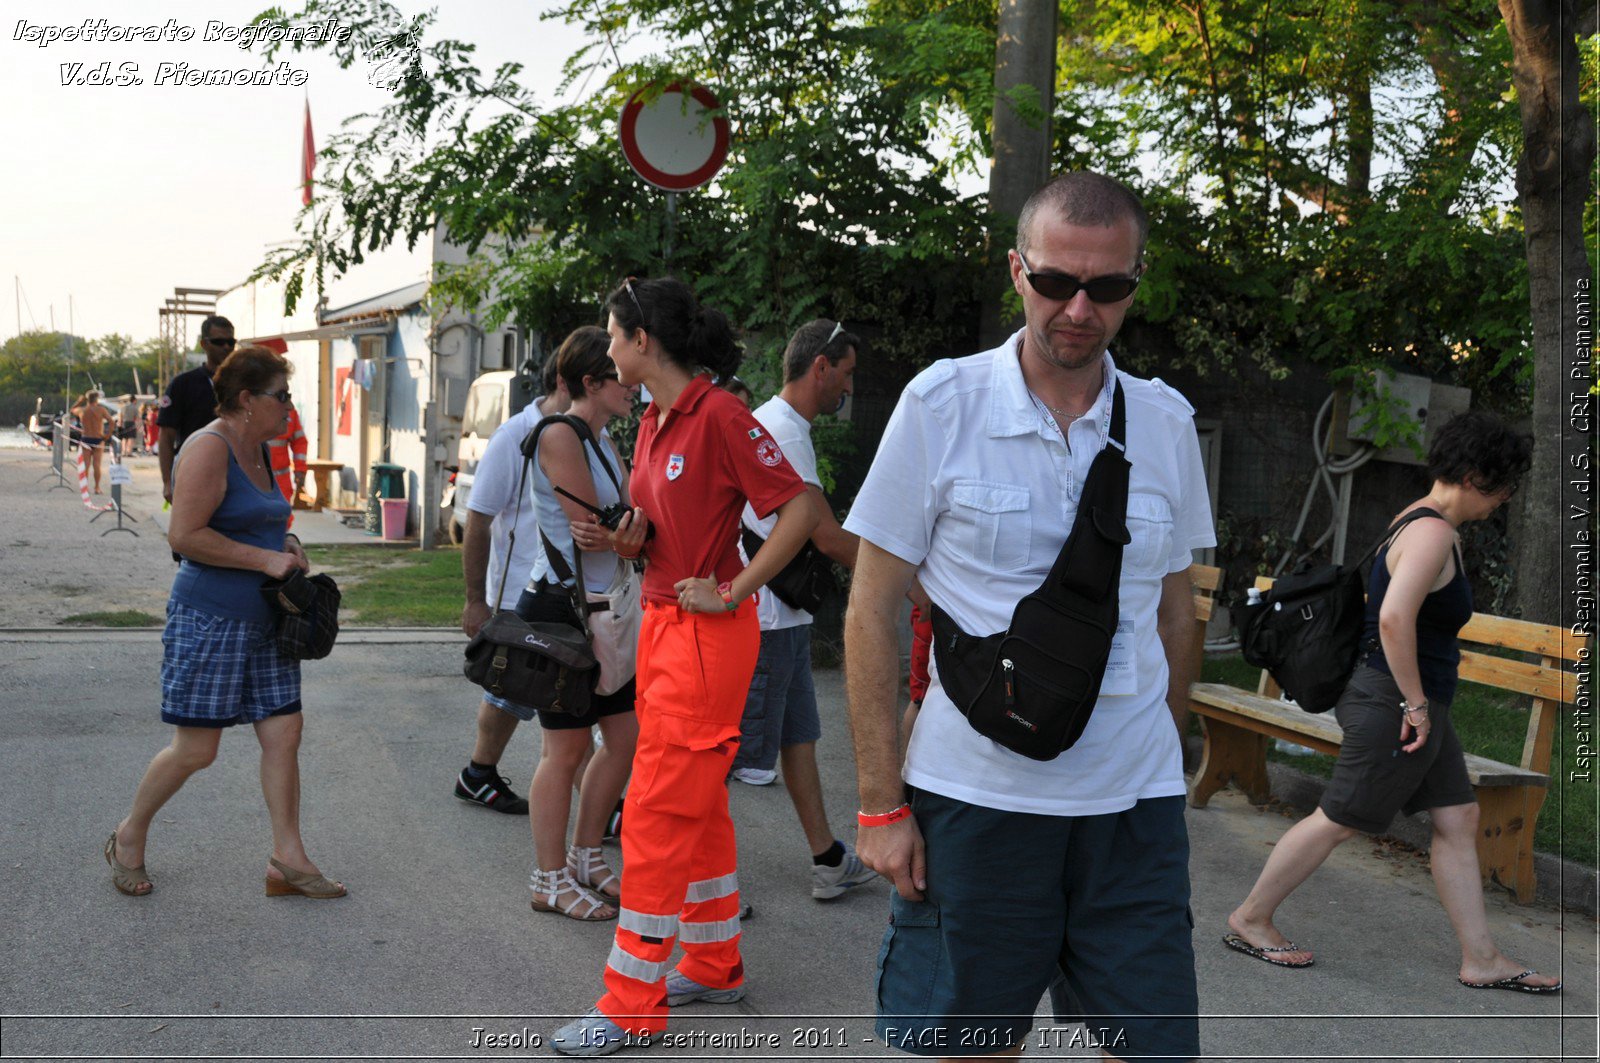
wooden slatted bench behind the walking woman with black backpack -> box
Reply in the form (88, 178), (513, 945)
(1189, 565), (1582, 905)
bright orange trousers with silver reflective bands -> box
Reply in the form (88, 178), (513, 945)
(600, 600), (762, 1034)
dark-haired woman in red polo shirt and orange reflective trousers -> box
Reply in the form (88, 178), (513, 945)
(552, 279), (818, 1055)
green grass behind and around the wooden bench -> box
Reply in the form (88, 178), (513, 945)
(1200, 653), (1600, 868)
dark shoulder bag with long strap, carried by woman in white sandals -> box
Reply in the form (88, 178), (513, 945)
(462, 423), (597, 717)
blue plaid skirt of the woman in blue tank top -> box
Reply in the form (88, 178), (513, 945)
(162, 602), (301, 727)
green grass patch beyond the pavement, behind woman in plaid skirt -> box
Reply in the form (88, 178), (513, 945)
(306, 546), (466, 628)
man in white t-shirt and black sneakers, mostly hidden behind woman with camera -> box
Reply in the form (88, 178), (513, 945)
(456, 354), (573, 815)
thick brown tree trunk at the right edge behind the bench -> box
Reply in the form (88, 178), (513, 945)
(1499, 0), (1595, 628)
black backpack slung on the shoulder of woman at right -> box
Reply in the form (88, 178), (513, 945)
(1238, 507), (1440, 712)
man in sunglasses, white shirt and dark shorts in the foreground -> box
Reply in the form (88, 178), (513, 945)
(845, 173), (1216, 1060)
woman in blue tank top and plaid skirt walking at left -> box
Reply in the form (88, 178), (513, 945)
(106, 347), (344, 898)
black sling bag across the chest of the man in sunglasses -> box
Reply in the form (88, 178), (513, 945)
(933, 381), (1131, 760)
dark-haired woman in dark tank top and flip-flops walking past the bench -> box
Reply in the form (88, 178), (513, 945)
(1222, 411), (1562, 993)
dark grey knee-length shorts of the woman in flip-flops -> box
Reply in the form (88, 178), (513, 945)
(1320, 664), (1477, 834)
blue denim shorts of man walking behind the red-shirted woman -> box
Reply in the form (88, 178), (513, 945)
(733, 624), (822, 772)
